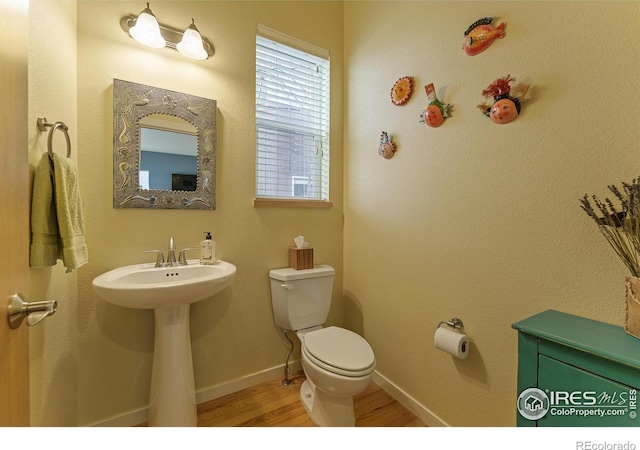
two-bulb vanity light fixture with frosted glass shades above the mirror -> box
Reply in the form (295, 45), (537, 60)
(120, 3), (214, 60)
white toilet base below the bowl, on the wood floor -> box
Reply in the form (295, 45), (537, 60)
(300, 380), (356, 427)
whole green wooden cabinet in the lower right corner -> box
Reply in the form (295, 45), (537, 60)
(513, 310), (640, 427)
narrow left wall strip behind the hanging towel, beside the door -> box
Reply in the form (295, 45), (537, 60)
(29, 0), (79, 426)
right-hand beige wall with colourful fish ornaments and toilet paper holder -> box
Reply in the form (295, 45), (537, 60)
(344, 1), (640, 426)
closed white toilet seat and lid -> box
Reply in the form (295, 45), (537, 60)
(302, 327), (376, 377)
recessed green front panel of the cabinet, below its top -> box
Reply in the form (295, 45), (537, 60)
(538, 355), (640, 427)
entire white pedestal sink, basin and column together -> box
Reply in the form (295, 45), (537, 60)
(93, 260), (236, 427)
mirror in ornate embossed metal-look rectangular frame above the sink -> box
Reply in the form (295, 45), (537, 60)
(113, 80), (216, 209)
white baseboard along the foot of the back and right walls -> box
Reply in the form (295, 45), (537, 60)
(90, 361), (449, 427)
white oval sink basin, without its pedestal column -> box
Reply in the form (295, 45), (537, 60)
(93, 260), (236, 309)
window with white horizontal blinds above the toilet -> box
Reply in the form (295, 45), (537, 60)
(256, 26), (329, 202)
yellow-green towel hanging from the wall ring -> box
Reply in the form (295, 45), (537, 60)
(31, 153), (89, 272)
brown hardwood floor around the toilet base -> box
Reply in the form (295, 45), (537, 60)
(198, 373), (425, 427)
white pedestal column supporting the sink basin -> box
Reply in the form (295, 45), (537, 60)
(149, 304), (198, 427)
